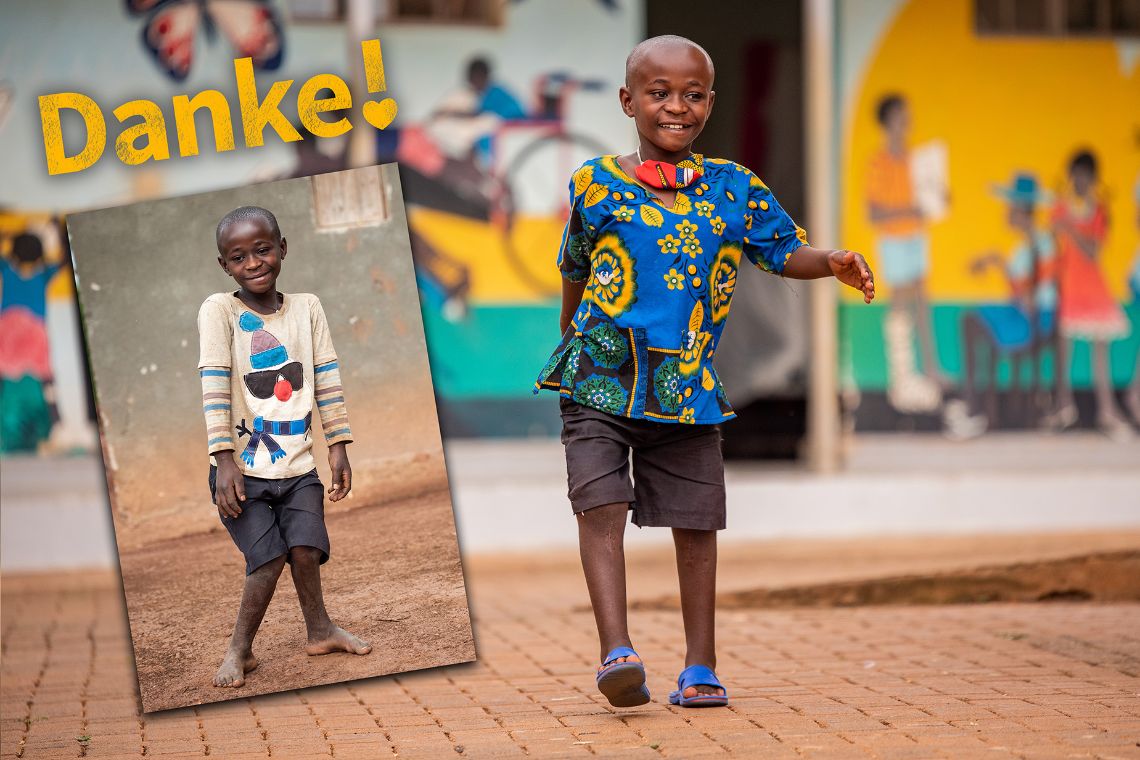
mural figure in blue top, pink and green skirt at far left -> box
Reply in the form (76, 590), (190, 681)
(0, 222), (66, 453)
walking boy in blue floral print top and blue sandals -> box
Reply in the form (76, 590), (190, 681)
(535, 35), (874, 706)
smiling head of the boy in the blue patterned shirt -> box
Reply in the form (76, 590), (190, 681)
(619, 41), (716, 162)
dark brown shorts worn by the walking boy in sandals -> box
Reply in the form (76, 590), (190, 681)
(559, 398), (725, 530)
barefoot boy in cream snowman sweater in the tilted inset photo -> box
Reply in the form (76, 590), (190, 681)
(198, 206), (372, 687)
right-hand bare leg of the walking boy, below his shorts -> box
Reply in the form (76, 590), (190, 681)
(673, 528), (724, 696)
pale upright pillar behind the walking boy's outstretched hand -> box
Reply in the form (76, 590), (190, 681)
(804, 0), (841, 473)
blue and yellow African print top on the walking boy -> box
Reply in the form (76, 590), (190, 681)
(535, 155), (807, 424)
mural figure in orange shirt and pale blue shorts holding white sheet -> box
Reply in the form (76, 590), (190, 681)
(868, 95), (945, 412)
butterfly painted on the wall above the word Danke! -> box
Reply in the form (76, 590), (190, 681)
(125, 0), (285, 81)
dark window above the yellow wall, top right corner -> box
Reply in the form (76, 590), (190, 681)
(974, 0), (1140, 36)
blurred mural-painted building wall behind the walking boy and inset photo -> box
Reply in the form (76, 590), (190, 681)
(0, 0), (1140, 572)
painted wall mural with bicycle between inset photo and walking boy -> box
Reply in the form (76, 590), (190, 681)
(377, 0), (643, 436)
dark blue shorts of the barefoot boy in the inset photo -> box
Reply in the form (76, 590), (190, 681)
(210, 465), (328, 575)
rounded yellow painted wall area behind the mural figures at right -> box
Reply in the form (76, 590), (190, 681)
(841, 0), (1140, 301)
